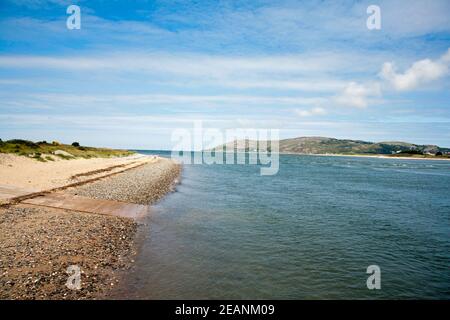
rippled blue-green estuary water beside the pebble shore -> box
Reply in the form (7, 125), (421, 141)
(120, 151), (450, 299)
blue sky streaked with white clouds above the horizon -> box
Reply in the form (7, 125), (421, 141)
(0, 0), (450, 149)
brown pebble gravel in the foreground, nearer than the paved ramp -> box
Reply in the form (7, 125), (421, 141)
(0, 205), (137, 299)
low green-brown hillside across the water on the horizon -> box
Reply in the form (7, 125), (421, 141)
(210, 137), (450, 155)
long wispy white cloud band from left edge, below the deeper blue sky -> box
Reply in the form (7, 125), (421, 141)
(0, 52), (373, 77)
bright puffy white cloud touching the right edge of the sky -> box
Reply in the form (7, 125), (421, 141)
(380, 49), (450, 91)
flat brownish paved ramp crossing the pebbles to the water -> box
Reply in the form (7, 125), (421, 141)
(22, 192), (149, 219)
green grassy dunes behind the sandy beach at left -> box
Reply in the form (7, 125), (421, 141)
(0, 139), (135, 162)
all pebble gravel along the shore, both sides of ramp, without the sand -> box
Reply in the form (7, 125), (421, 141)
(0, 158), (181, 299)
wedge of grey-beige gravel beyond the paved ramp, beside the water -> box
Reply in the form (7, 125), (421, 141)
(67, 158), (181, 205)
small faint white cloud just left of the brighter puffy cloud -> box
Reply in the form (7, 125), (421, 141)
(334, 82), (381, 108)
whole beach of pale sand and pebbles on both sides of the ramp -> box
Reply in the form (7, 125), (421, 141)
(0, 154), (181, 299)
